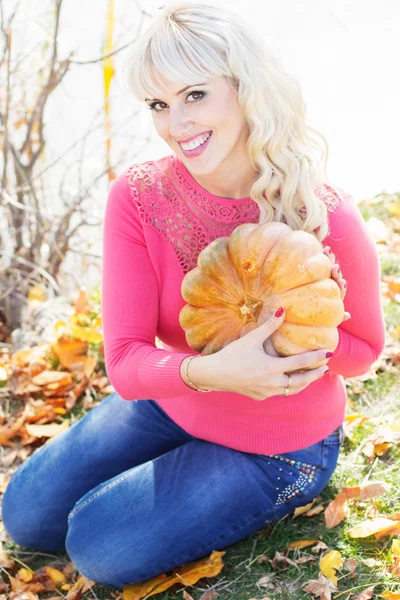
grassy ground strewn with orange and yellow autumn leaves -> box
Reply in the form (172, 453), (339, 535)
(0, 194), (400, 600)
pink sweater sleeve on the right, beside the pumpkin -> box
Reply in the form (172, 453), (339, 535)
(323, 188), (385, 377)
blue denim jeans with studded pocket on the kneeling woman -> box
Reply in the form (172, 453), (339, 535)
(2, 392), (343, 588)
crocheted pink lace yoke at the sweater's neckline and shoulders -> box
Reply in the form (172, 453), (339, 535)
(127, 156), (346, 274)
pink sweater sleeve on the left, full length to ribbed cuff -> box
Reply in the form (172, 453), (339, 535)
(101, 171), (199, 400)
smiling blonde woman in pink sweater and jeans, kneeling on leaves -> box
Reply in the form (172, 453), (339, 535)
(3, 2), (384, 587)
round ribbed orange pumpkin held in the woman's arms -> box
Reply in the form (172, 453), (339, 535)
(179, 222), (344, 370)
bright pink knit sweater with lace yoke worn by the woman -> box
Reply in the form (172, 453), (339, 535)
(102, 154), (385, 454)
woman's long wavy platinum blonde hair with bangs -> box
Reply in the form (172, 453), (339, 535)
(124, 0), (329, 241)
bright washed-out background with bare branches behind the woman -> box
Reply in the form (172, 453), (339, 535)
(0, 0), (400, 328)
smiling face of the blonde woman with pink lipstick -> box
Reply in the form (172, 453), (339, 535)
(146, 76), (249, 175)
